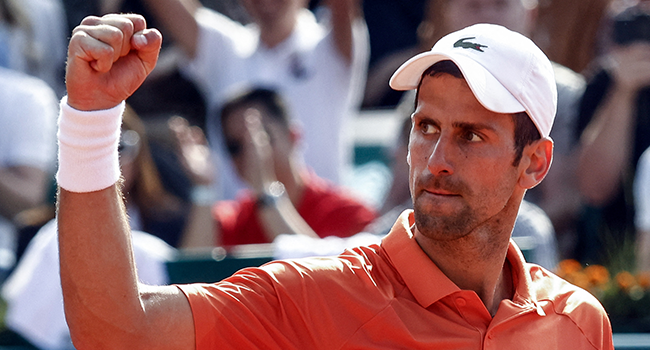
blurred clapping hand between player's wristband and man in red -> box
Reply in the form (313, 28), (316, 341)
(167, 117), (215, 186)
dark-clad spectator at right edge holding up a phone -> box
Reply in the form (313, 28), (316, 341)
(576, 2), (650, 263)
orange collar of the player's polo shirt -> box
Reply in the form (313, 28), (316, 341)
(381, 210), (537, 308)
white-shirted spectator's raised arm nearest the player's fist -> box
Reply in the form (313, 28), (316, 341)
(144, 0), (202, 58)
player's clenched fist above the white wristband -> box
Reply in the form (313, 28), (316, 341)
(66, 14), (162, 111)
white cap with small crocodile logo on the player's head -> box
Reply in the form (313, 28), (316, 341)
(390, 24), (557, 137)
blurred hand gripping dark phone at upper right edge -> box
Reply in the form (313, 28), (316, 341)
(607, 43), (650, 93)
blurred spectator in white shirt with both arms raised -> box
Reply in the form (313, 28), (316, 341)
(139, 0), (368, 198)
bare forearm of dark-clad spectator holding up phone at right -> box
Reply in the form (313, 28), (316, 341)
(577, 85), (636, 205)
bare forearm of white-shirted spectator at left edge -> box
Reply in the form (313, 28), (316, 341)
(0, 166), (47, 220)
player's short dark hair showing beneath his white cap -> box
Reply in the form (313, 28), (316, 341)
(414, 60), (542, 166)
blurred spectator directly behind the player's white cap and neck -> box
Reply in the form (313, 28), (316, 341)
(368, 0), (585, 263)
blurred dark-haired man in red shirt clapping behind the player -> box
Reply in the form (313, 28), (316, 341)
(176, 88), (375, 247)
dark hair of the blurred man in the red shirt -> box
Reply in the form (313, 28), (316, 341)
(221, 87), (290, 128)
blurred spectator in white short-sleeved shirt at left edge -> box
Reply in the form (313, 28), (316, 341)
(0, 68), (57, 279)
